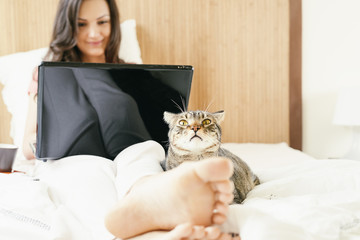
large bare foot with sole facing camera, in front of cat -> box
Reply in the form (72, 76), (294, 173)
(105, 158), (234, 238)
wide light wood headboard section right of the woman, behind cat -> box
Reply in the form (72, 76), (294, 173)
(118, 0), (289, 142)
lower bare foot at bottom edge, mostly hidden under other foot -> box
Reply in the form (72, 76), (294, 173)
(128, 223), (240, 240)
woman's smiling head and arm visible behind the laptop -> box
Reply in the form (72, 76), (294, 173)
(23, 0), (124, 159)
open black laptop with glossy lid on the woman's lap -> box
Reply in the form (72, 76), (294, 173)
(35, 62), (193, 160)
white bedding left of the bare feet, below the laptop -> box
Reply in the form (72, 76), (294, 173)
(0, 156), (117, 240)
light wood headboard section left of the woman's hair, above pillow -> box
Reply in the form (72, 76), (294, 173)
(0, 0), (58, 56)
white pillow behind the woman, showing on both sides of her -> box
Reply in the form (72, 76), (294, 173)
(0, 19), (142, 159)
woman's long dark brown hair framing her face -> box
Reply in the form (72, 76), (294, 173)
(45, 0), (124, 63)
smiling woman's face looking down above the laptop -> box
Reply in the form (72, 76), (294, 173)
(77, 0), (111, 62)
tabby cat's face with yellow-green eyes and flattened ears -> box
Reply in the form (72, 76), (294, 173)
(164, 111), (225, 154)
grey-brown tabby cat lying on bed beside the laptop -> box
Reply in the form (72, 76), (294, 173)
(164, 110), (260, 203)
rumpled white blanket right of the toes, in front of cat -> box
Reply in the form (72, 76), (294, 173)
(224, 160), (360, 240)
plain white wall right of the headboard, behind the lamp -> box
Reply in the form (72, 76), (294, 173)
(302, 0), (360, 158)
